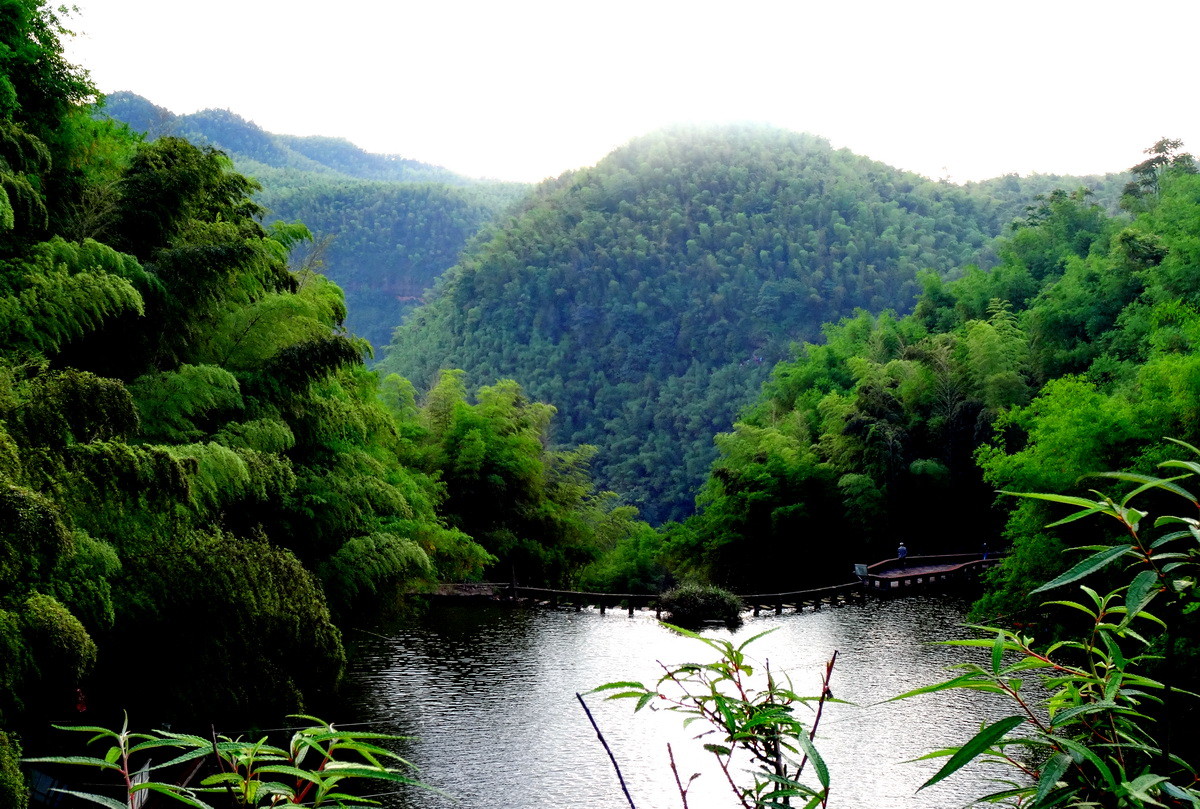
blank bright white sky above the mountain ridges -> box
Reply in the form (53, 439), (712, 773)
(66, 0), (1200, 181)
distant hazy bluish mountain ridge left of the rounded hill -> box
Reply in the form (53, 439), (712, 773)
(103, 92), (527, 347)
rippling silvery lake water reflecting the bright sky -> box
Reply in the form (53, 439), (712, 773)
(340, 597), (1012, 809)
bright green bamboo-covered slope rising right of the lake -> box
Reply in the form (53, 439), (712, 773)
(667, 140), (1200, 597)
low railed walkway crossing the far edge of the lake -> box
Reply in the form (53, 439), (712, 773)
(438, 553), (1001, 618)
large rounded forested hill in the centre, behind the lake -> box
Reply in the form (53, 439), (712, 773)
(384, 127), (1123, 521)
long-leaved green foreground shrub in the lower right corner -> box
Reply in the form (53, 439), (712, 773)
(896, 456), (1200, 809)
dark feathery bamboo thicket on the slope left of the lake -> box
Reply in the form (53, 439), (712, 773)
(0, 7), (649, 808)
